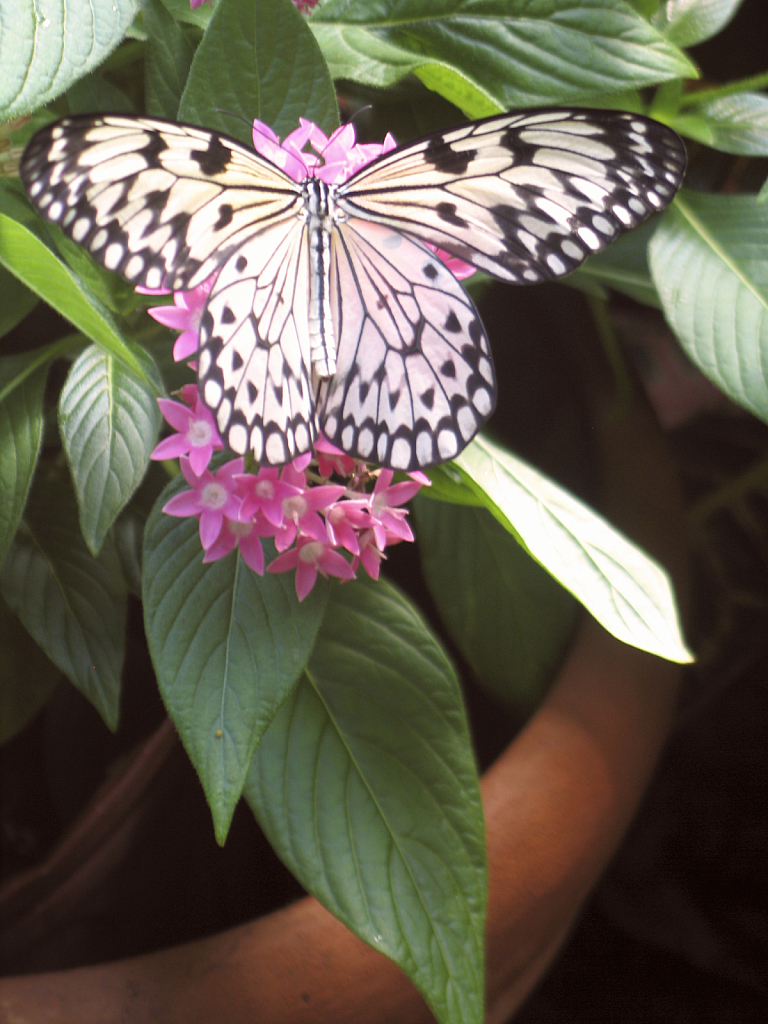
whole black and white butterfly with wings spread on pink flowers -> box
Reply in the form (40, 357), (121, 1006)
(20, 108), (685, 471)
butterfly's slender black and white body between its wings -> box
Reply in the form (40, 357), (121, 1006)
(302, 178), (336, 380)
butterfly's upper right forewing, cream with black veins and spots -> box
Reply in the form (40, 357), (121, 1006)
(336, 108), (685, 285)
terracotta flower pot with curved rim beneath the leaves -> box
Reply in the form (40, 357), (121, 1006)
(0, 380), (685, 1024)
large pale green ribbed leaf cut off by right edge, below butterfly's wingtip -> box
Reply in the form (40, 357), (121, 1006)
(650, 191), (768, 421)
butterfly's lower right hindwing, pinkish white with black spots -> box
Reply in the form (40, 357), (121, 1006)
(318, 219), (496, 471)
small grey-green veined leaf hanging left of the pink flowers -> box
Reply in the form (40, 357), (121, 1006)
(58, 345), (163, 555)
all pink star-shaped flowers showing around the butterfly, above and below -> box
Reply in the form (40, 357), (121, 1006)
(139, 119), (475, 600)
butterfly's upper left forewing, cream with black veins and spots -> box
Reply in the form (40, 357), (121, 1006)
(20, 116), (302, 291)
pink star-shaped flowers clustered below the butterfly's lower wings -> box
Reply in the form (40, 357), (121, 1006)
(152, 384), (429, 601)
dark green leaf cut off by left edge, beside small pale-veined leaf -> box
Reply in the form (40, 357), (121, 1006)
(0, 352), (48, 565)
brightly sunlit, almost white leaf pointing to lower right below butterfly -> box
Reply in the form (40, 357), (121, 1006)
(454, 436), (692, 662)
